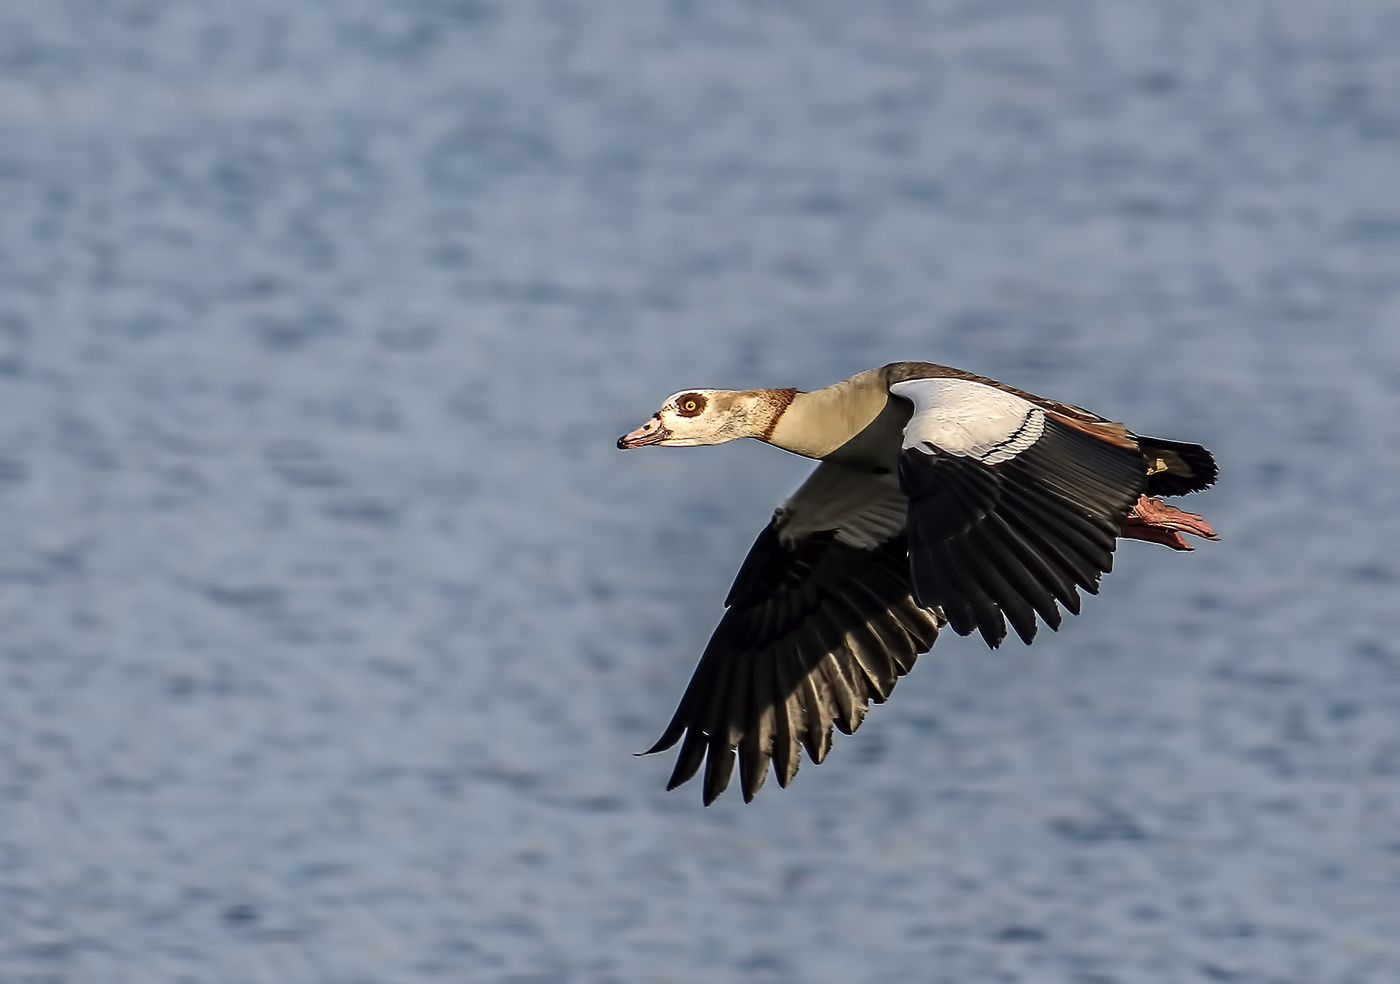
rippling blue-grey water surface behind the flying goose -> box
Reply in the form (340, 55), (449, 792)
(0, 0), (1400, 984)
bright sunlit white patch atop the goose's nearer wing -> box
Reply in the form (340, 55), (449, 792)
(889, 379), (1046, 465)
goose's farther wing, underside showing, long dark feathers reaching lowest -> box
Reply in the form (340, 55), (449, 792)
(648, 462), (941, 805)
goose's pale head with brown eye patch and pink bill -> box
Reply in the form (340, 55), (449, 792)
(617, 389), (794, 449)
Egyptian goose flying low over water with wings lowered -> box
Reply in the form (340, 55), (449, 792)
(617, 363), (1218, 806)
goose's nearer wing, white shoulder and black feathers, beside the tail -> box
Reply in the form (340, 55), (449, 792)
(890, 378), (1147, 647)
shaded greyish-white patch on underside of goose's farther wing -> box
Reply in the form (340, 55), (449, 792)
(773, 462), (909, 550)
